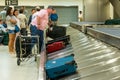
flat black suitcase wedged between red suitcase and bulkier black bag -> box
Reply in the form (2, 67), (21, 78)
(46, 35), (70, 45)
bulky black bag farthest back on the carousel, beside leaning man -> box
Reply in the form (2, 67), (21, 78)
(47, 26), (66, 39)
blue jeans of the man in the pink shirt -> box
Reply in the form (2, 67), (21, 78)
(30, 25), (44, 52)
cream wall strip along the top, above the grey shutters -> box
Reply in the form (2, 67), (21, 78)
(0, 0), (83, 10)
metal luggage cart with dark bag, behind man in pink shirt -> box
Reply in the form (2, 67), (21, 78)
(16, 35), (39, 66)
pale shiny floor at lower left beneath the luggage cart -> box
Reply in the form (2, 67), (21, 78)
(0, 46), (38, 80)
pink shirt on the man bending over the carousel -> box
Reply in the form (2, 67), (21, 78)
(31, 9), (48, 30)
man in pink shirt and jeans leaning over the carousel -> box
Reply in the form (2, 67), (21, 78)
(30, 6), (53, 51)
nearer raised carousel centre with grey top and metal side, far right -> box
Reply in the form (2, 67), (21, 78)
(87, 27), (120, 49)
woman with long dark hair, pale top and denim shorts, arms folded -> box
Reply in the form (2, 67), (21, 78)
(6, 7), (17, 54)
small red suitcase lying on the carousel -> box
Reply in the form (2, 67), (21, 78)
(47, 41), (65, 53)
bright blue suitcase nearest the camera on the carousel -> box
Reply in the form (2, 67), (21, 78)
(45, 54), (77, 79)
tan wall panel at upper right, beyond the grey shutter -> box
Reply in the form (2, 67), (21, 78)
(84, 0), (110, 21)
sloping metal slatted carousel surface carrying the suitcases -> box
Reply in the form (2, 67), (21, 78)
(39, 23), (120, 80)
